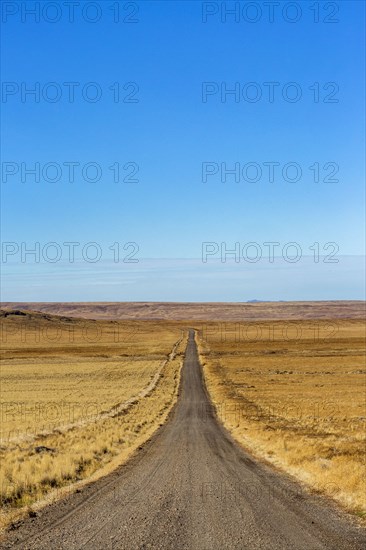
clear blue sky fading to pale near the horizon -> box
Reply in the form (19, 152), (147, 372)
(1, 0), (365, 301)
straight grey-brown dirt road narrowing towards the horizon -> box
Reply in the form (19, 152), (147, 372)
(2, 332), (366, 550)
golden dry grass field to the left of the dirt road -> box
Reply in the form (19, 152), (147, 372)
(0, 311), (187, 526)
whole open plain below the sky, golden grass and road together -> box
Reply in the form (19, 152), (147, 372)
(1, 303), (366, 550)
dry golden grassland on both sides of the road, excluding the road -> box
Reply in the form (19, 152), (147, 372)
(0, 303), (366, 526)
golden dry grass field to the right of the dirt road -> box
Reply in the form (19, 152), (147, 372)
(197, 319), (366, 516)
